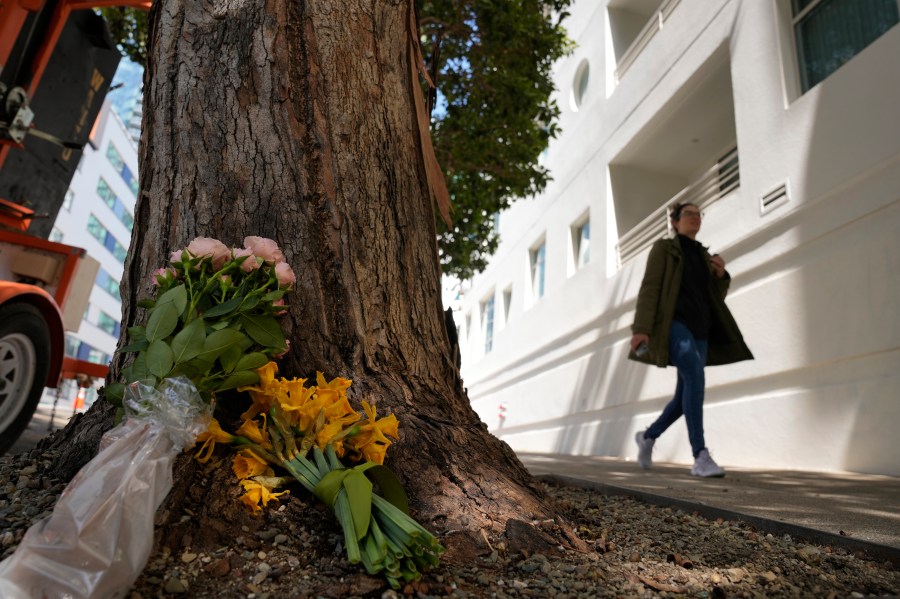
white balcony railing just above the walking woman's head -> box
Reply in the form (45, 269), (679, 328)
(617, 148), (741, 265)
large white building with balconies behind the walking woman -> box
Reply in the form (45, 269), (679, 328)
(457, 0), (900, 475)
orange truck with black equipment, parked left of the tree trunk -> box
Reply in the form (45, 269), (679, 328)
(0, 0), (150, 453)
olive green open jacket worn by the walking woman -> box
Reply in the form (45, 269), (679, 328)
(628, 237), (753, 368)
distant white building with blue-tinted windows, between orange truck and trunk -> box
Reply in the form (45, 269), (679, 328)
(48, 101), (138, 404)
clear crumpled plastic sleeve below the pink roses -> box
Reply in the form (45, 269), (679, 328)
(0, 379), (211, 599)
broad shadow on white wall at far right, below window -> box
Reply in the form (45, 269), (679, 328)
(798, 47), (900, 475)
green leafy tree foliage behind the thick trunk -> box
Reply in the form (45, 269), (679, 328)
(103, 0), (571, 279)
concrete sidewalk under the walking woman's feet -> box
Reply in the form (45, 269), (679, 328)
(517, 453), (900, 564)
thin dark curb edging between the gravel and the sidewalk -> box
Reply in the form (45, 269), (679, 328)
(536, 474), (900, 567)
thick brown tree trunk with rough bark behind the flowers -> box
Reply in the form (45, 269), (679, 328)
(47, 0), (576, 564)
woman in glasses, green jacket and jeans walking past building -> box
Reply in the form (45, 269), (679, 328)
(628, 203), (753, 477)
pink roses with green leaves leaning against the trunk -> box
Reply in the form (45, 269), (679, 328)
(106, 236), (295, 405)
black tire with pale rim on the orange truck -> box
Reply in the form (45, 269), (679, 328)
(0, 303), (50, 454)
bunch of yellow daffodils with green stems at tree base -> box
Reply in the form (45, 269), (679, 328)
(197, 362), (444, 588)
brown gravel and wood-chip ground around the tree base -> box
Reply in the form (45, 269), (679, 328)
(0, 449), (900, 599)
